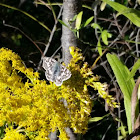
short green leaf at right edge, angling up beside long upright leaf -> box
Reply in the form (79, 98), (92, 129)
(127, 59), (140, 80)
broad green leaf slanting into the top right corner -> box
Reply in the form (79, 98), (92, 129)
(102, 0), (140, 27)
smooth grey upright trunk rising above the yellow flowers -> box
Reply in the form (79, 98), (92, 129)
(61, 0), (82, 65)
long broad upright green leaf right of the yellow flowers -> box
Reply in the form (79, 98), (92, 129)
(106, 53), (135, 134)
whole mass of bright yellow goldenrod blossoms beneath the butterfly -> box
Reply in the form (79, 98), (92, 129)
(0, 47), (118, 140)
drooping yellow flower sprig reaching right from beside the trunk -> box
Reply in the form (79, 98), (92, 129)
(69, 47), (119, 108)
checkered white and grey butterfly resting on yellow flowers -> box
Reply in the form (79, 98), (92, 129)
(42, 57), (71, 86)
